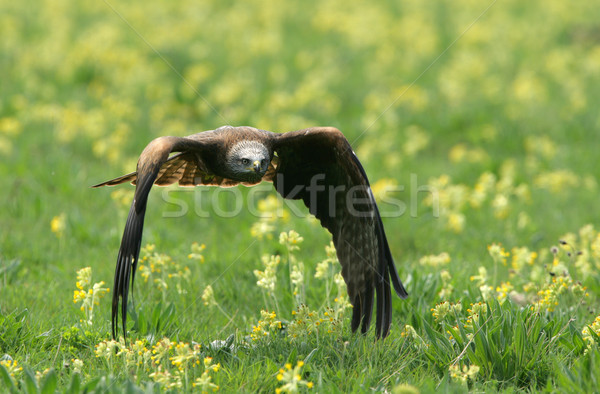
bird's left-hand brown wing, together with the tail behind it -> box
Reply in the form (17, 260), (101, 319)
(93, 137), (225, 338)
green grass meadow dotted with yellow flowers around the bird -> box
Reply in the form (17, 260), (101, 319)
(0, 0), (600, 393)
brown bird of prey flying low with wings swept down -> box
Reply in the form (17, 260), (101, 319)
(93, 126), (408, 338)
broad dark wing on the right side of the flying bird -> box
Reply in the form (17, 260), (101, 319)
(273, 127), (408, 337)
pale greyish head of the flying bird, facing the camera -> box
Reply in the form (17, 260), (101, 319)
(226, 141), (271, 182)
